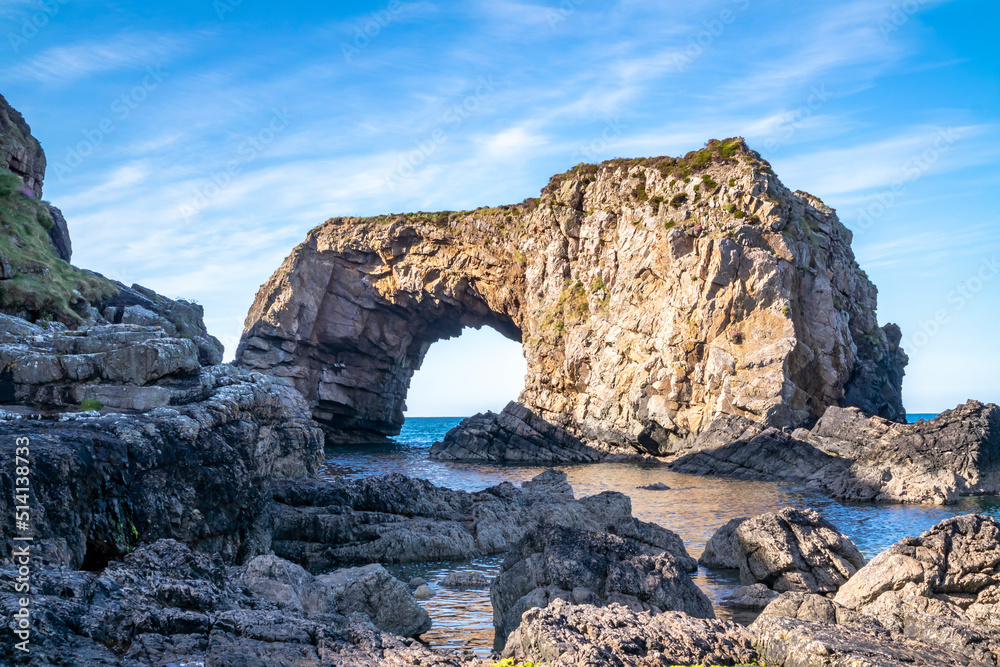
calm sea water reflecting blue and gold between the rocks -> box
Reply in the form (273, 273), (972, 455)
(324, 415), (1000, 656)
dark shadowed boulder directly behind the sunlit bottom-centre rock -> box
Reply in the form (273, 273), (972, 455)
(490, 526), (715, 646)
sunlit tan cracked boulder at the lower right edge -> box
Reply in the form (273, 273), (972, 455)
(835, 514), (1000, 634)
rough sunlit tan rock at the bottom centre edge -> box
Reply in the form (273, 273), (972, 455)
(503, 599), (770, 667)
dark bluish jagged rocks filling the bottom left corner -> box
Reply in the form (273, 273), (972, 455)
(0, 540), (468, 667)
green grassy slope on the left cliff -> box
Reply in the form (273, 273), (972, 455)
(0, 168), (115, 324)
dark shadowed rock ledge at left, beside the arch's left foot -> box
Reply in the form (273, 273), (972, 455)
(0, 365), (323, 568)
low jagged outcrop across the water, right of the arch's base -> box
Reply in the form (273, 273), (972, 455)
(670, 401), (1000, 504)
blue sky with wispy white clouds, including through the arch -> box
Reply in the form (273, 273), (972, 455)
(0, 0), (1000, 415)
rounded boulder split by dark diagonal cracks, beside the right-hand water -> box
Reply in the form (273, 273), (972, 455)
(734, 507), (865, 593)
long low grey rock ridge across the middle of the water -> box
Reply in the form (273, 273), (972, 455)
(271, 470), (698, 572)
